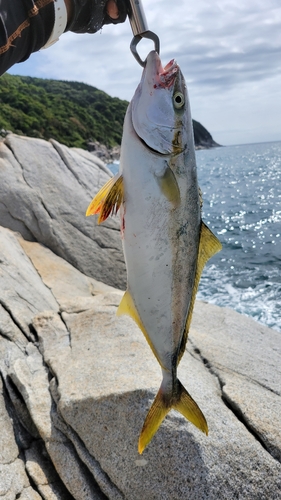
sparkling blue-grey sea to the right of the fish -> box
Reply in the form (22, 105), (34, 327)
(108, 141), (281, 331)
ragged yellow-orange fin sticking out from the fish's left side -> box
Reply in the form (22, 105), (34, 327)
(86, 173), (124, 224)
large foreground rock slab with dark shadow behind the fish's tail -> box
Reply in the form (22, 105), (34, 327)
(34, 305), (281, 499)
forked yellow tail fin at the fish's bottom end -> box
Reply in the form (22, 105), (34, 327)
(138, 379), (208, 454)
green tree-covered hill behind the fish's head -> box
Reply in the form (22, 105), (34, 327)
(0, 73), (219, 148)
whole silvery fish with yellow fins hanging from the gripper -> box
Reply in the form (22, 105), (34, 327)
(86, 51), (222, 454)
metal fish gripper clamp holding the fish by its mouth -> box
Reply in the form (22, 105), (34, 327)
(128, 0), (160, 68)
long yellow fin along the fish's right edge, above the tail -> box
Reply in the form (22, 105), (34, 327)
(178, 221), (222, 364)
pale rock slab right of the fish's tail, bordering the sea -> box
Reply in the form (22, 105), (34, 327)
(190, 302), (281, 396)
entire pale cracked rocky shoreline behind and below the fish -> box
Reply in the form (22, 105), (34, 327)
(0, 134), (281, 500)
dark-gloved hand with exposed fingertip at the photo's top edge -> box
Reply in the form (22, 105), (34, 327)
(65, 0), (127, 33)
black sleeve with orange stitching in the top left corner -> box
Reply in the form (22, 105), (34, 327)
(0, 0), (55, 75)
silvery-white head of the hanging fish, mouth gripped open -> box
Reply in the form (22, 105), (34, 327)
(131, 51), (188, 155)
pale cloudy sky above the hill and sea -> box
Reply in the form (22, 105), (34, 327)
(9, 0), (281, 145)
